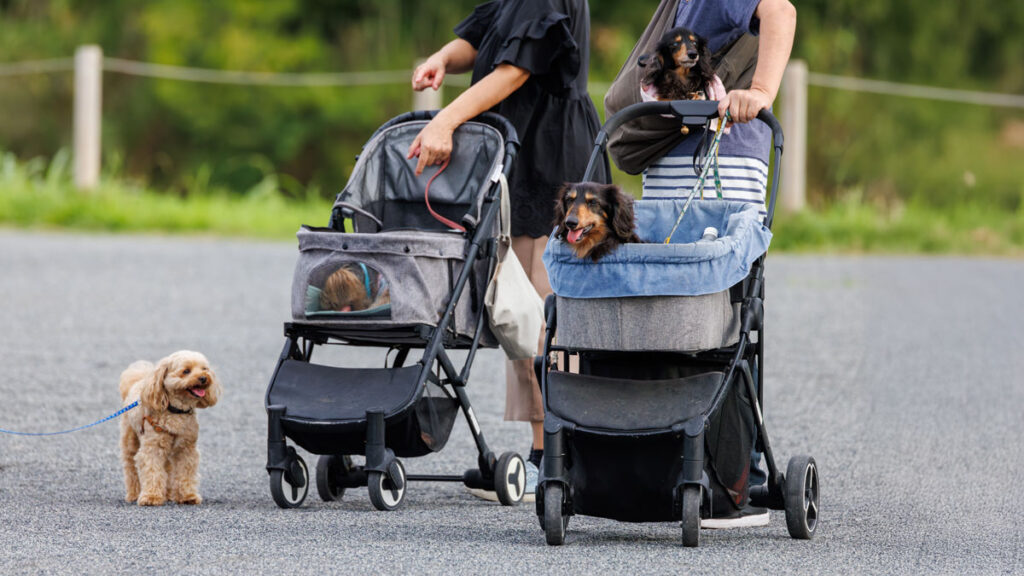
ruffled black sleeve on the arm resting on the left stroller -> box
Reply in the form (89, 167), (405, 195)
(492, 10), (580, 89)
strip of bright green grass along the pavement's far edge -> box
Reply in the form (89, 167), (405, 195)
(0, 153), (1024, 253)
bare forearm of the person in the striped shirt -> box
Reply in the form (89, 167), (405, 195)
(751, 0), (797, 100)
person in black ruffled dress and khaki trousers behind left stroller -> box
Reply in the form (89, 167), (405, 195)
(409, 0), (609, 501)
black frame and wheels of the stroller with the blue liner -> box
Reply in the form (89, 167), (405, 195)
(535, 100), (818, 546)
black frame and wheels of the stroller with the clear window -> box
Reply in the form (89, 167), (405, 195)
(266, 111), (525, 510)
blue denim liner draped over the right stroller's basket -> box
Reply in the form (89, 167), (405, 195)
(544, 199), (771, 298)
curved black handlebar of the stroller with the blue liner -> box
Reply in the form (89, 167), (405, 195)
(583, 100), (783, 229)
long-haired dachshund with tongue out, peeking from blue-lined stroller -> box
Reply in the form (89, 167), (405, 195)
(554, 182), (640, 262)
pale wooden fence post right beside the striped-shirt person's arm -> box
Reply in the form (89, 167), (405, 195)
(779, 60), (807, 212)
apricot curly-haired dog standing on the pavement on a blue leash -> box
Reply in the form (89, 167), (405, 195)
(119, 351), (220, 506)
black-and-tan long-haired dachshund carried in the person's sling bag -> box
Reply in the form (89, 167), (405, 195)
(637, 28), (715, 100)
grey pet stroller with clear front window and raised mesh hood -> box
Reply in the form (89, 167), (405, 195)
(265, 112), (525, 510)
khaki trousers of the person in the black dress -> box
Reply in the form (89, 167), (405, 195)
(505, 236), (551, 422)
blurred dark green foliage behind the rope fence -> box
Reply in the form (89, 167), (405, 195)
(0, 0), (1024, 207)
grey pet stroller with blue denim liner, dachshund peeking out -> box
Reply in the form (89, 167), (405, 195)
(535, 101), (818, 546)
